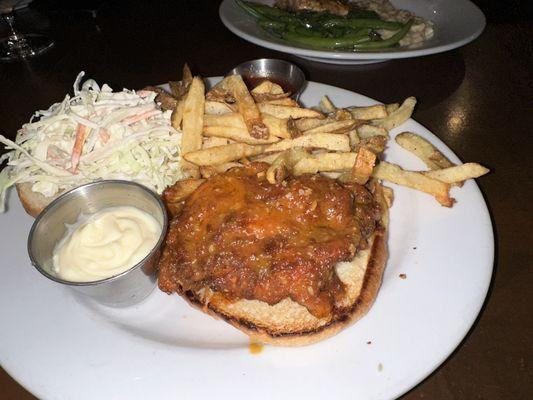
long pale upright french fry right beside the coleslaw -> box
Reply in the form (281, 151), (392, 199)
(181, 77), (205, 177)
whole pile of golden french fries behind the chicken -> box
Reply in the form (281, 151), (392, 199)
(160, 66), (489, 207)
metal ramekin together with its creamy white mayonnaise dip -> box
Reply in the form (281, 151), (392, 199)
(28, 180), (168, 307)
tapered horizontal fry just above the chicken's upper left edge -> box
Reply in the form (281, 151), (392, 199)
(183, 143), (266, 166)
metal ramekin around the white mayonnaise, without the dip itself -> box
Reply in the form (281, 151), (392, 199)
(28, 180), (168, 307)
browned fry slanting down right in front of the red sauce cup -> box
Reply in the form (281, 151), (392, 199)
(222, 75), (268, 139)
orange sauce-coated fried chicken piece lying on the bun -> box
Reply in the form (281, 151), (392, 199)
(159, 163), (379, 317)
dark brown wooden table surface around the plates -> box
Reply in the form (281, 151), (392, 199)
(0, 0), (533, 400)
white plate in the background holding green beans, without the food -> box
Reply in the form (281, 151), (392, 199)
(219, 0), (485, 65)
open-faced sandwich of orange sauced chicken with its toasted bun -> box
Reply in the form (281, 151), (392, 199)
(159, 163), (388, 345)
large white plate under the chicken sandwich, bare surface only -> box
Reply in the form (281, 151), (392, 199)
(0, 79), (493, 400)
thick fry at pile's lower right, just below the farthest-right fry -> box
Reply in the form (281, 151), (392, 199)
(372, 161), (455, 207)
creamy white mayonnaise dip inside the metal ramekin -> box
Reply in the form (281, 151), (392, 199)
(53, 206), (162, 282)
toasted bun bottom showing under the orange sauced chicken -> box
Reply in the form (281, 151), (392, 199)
(177, 186), (388, 346)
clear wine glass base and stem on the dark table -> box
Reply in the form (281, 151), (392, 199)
(0, 0), (54, 61)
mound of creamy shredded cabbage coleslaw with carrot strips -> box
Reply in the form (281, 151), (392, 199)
(0, 71), (185, 212)
